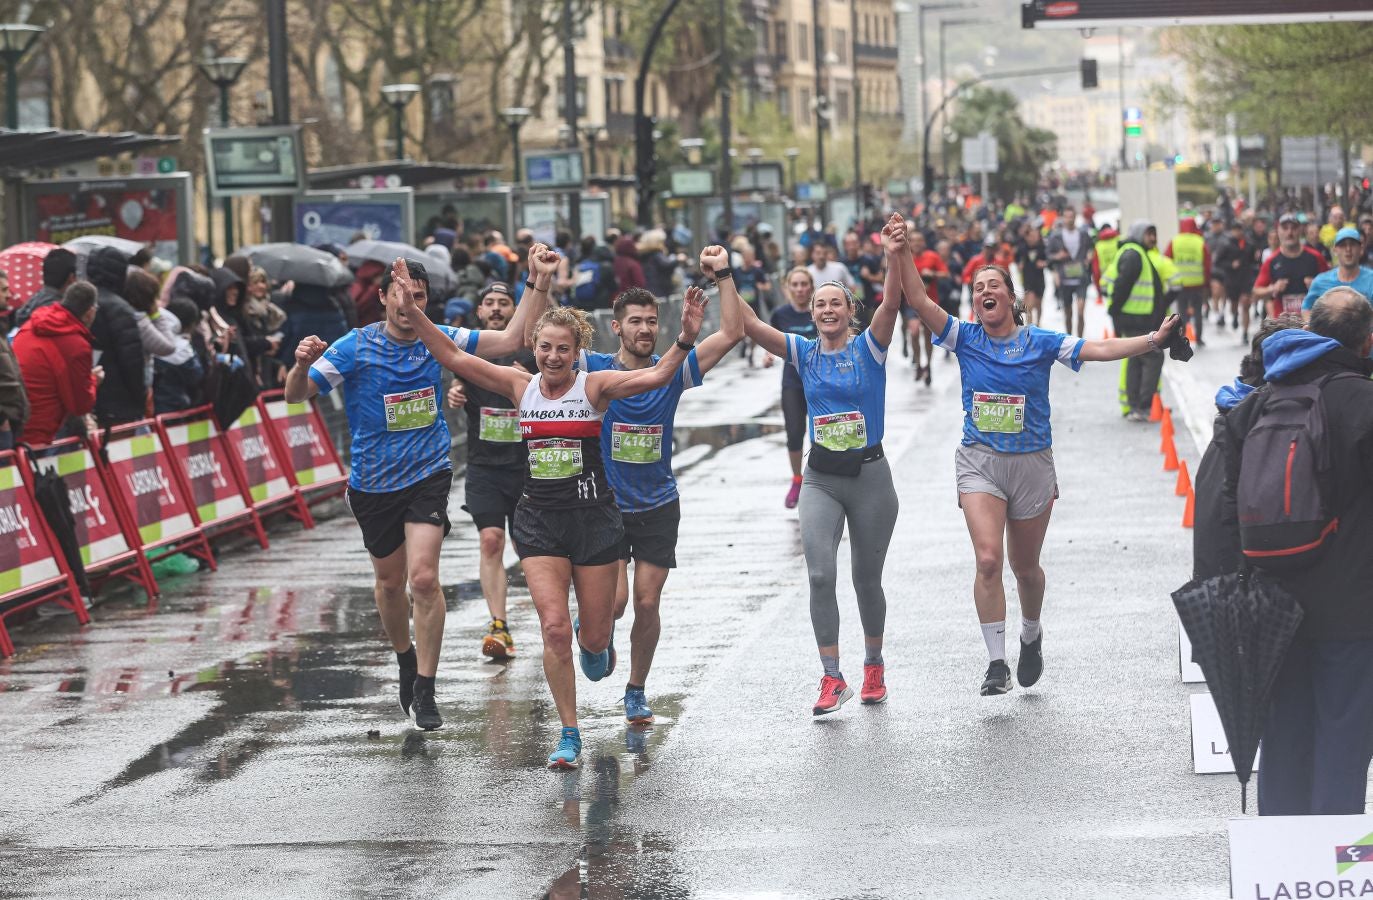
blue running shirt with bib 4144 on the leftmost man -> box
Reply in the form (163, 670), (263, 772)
(310, 322), (479, 493)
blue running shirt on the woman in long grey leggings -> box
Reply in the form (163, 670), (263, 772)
(787, 328), (887, 451)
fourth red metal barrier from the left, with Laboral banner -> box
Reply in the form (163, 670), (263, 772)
(157, 407), (268, 550)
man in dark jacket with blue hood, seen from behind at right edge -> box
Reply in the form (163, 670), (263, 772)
(1225, 287), (1373, 816)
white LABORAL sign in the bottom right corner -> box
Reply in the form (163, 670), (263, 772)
(1229, 815), (1373, 900)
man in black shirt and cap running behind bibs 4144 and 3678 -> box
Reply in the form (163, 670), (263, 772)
(448, 281), (541, 660)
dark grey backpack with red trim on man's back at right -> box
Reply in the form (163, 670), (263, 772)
(1236, 372), (1359, 573)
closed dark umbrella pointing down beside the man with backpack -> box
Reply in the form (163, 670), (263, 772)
(1173, 572), (1302, 812)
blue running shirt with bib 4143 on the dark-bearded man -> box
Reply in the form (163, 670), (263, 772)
(579, 350), (703, 513)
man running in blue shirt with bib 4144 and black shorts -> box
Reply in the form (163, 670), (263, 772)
(286, 252), (548, 731)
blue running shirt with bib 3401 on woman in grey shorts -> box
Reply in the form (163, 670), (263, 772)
(935, 316), (1085, 453)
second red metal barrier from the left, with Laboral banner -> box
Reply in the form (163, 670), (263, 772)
(22, 437), (158, 602)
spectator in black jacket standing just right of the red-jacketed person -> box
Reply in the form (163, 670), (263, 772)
(86, 247), (147, 426)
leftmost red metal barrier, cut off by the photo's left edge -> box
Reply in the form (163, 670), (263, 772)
(0, 451), (91, 657)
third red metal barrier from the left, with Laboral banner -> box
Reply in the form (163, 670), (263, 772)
(99, 419), (217, 569)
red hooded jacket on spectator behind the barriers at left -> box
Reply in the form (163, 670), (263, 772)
(14, 304), (96, 444)
